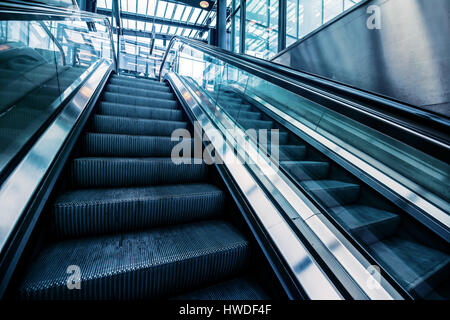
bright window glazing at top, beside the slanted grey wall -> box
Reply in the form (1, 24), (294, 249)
(233, 0), (362, 59)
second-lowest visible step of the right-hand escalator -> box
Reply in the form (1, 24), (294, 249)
(330, 205), (400, 244)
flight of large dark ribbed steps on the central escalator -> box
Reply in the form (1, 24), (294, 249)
(14, 76), (269, 300)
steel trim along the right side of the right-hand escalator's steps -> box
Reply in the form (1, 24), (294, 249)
(233, 85), (450, 242)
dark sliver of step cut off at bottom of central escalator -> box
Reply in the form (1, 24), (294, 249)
(174, 278), (270, 300)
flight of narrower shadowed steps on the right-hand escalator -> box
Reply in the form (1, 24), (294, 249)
(206, 88), (450, 299)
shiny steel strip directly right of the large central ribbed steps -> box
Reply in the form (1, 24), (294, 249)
(166, 73), (343, 300)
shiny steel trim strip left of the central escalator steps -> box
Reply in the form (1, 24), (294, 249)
(0, 60), (112, 255)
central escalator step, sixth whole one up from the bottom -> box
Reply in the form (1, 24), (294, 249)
(98, 102), (183, 121)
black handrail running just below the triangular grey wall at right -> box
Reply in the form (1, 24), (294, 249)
(160, 36), (450, 161)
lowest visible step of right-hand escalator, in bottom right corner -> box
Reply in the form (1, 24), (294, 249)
(370, 237), (450, 297)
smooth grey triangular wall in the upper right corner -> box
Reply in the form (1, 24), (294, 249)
(272, 0), (450, 117)
